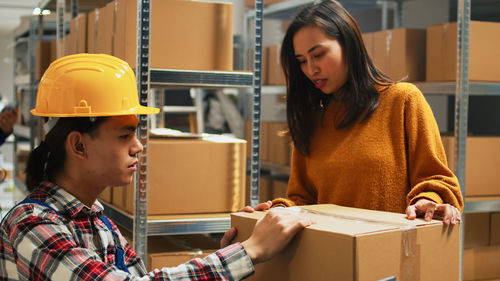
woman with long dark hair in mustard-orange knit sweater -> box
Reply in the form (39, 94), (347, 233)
(261, 0), (463, 224)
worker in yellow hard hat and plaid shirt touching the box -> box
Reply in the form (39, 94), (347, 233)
(0, 54), (311, 280)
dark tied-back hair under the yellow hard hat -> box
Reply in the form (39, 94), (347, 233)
(26, 117), (107, 191)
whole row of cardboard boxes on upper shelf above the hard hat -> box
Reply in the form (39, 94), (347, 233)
(36, 0), (233, 76)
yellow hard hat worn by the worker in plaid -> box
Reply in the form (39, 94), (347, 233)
(31, 54), (160, 117)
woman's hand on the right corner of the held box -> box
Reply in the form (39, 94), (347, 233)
(406, 198), (462, 225)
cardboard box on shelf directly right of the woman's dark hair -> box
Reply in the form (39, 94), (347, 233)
(372, 28), (426, 81)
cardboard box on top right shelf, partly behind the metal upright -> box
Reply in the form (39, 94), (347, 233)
(426, 21), (500, 81)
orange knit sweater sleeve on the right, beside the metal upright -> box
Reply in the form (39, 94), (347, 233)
(404, 84), (463, 210)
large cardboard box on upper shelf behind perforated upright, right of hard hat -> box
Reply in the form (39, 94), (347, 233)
(114, 0), (233, 71)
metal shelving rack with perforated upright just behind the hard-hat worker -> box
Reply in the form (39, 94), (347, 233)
(33, 0), (254, 261)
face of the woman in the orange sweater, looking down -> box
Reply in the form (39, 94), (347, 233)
(293, 26), (347, 94)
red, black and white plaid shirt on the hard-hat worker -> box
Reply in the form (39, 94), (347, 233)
(0, 183), (254, 280)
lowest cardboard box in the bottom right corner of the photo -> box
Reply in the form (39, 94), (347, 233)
(457, 246), (500, 281)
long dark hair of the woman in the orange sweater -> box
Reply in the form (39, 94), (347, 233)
(281, 0), (394, 155)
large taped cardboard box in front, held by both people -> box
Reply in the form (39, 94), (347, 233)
(231, 204), (460, 281)
